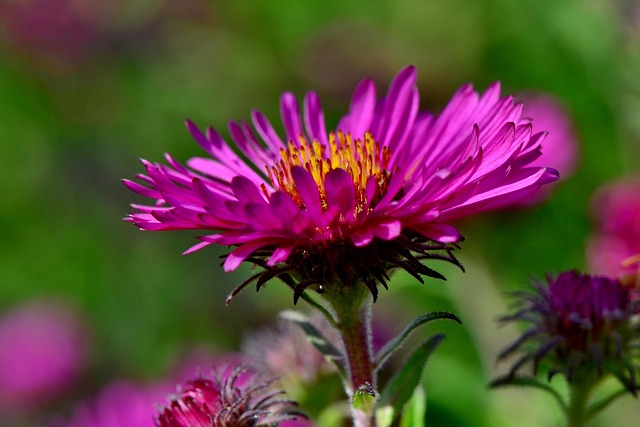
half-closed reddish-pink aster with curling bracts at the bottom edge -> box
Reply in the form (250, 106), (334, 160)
(156, 367), (304, 427)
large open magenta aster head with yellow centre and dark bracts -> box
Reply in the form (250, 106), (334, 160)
(124, 67), (557, 298)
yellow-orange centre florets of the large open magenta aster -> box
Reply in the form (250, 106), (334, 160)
(262, 131), (391, 214)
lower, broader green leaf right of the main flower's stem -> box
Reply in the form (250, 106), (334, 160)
(378, 334), (444, 421)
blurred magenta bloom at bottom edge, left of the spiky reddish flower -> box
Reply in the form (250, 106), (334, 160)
(55, 380), (168, 427)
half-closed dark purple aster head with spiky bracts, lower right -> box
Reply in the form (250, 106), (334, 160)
(499, 271), (640, 393)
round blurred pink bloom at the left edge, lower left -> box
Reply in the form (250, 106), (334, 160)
(0, 300), (88, 408)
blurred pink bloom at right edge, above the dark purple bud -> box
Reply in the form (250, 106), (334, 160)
(587, 178), (640, 275)
